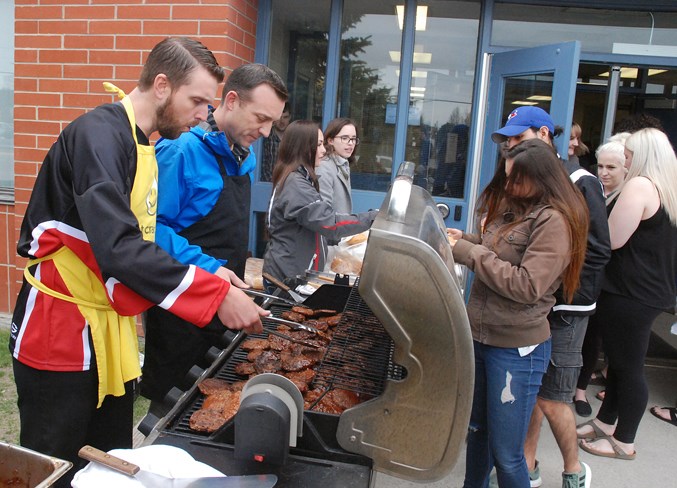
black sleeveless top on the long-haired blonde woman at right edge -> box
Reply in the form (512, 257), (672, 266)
(602, 206), (677, 310)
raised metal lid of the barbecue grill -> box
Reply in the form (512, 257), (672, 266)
(337, 163), (474, 481)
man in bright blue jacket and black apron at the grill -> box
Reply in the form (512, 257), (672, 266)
(141, 64), (288, 415)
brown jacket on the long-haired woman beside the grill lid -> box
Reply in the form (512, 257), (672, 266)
(454, 206), (570, 347)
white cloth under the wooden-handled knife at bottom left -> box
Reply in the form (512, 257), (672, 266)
(71, 444), (225, 488)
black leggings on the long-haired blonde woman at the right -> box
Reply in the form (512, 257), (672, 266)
(595, 292), (661, 443)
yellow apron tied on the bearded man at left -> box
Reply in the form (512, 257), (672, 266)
(24, 84), (158, 408)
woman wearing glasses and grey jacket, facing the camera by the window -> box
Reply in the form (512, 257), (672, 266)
(317, 118), (360, 214)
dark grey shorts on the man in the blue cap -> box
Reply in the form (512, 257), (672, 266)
(538, 314), (589, 403)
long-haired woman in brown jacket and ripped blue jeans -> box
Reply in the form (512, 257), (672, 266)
(449, 139), (588, 488)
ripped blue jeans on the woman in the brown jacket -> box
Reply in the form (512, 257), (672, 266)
(463, 339), (551, 488)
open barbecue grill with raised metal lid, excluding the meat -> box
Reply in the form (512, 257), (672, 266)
(142, 163), (474, 488)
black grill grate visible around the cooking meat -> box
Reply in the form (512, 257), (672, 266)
(168, 282), (405, 437)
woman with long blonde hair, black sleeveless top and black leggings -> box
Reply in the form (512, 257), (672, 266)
(577, 128), (677, 459)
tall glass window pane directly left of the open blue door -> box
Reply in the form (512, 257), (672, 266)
(406, 1), (480, 198)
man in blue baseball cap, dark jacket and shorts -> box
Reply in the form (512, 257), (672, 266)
(491, 106), (611, 488)
